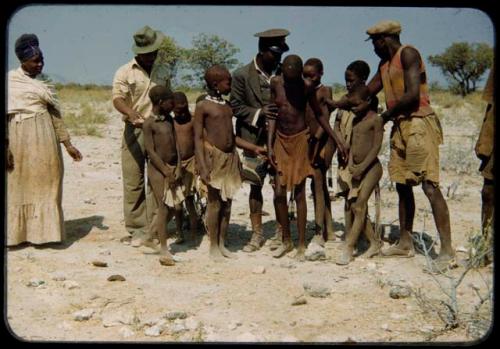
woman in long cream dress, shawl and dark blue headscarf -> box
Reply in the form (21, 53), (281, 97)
(7, 34), (82, 246)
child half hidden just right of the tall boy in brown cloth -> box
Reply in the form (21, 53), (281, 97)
(302, 58), (336, 246)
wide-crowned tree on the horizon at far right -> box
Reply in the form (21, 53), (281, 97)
(428, 42), (493, 96)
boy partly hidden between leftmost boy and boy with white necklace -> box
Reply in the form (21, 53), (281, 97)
(173, 92), (198, 243)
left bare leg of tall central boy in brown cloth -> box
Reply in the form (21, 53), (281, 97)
(273, 181), (293, 258)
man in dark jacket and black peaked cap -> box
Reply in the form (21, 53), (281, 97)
(230, 29), (290, 252)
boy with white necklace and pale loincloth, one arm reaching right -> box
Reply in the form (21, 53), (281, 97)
(194, 65), (265, 260)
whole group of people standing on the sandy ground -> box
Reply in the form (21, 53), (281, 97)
(8, 21), (494, 270)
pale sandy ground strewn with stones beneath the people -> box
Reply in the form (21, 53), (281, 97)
(6, 100), (493, 343)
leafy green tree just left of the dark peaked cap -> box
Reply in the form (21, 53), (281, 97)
(183, 33), (240, 83)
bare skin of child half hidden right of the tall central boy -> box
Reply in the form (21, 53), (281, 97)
(302, 64), (336, 245)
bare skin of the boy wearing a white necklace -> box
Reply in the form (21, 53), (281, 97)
(194, 70), (265, 261)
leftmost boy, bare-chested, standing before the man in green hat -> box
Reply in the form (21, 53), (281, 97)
(143, 85), (184, 265)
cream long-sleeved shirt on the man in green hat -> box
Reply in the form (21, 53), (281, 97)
(112, 58), (156, 120)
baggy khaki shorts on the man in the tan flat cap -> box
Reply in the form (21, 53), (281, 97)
(389, 114), (443, 185)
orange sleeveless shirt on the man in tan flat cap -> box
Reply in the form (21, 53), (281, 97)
(380, 45), (434, 116)
